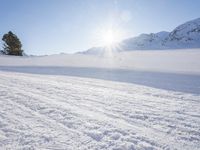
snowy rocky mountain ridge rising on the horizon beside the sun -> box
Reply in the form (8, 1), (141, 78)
(82, 18), (200, 54)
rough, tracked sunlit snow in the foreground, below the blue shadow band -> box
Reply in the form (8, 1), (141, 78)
(0, 71), (200, 150)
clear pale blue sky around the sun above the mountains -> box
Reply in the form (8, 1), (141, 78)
(0, 0), (200, 55)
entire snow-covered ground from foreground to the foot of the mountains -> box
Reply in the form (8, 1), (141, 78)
(0, 49), (200, 150)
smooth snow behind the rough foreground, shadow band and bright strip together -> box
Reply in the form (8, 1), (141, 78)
(0, 49), (200, 94)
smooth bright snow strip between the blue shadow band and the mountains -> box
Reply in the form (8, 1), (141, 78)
(0, 49), (200, 74)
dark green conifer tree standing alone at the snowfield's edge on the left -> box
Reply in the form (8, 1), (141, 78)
(2, 31), (23, 56)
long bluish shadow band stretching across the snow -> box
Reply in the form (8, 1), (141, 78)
(0, 66), (200, 94)
